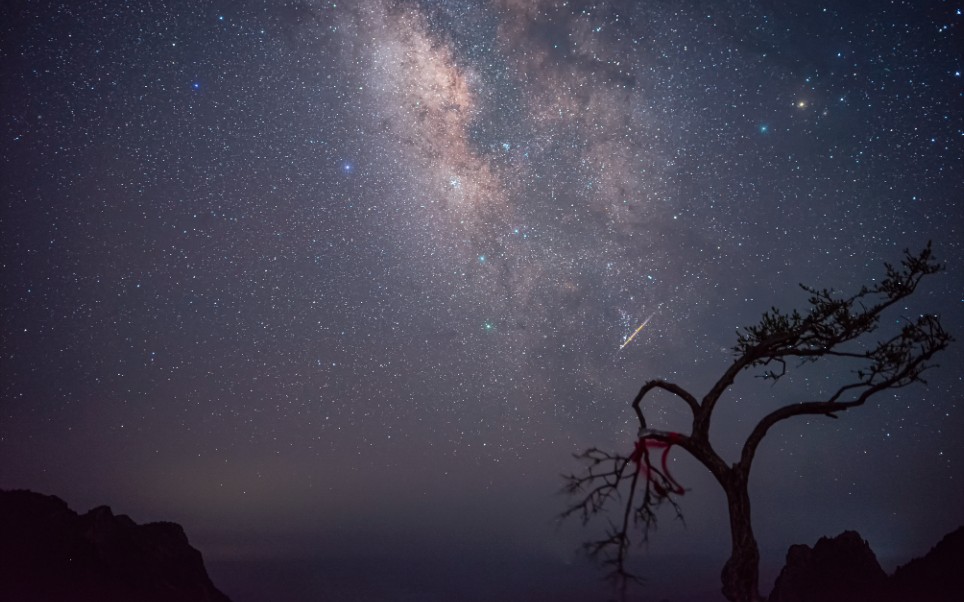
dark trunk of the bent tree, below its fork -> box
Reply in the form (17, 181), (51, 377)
(722, 466), (762, 602)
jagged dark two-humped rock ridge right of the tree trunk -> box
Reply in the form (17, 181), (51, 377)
(769, 527), (964, 602)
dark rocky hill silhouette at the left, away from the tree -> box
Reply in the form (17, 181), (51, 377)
(0, 491), (229, 602)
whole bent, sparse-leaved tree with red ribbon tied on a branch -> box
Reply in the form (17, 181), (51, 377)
(563, 243), (953, 602)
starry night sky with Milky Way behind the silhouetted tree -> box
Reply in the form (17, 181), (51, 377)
(0, 0), (964, 602)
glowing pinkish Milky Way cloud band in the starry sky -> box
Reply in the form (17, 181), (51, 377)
(328, 3), (695, 380)
